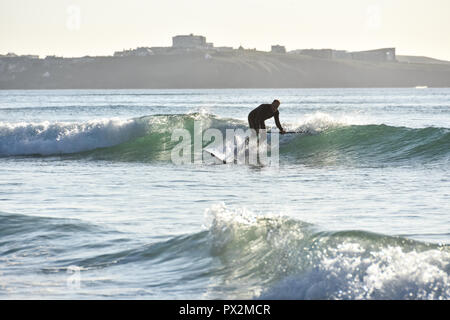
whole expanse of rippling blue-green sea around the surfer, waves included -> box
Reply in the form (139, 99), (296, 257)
(0, 89), (450, 299)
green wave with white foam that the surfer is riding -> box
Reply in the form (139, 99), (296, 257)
(0, 113), (450, 164)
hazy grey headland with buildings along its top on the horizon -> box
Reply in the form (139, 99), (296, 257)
(0, 36), (450, 89)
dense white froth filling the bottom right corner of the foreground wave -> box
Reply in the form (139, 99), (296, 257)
(259, 242), (450, 300)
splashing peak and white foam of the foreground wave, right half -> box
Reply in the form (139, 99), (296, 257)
(206, 204), (450, 299)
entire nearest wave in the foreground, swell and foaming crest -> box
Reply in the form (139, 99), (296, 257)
(0, 204), (450, 300)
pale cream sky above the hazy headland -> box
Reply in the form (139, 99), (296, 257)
(0, 0), (450, 60)
